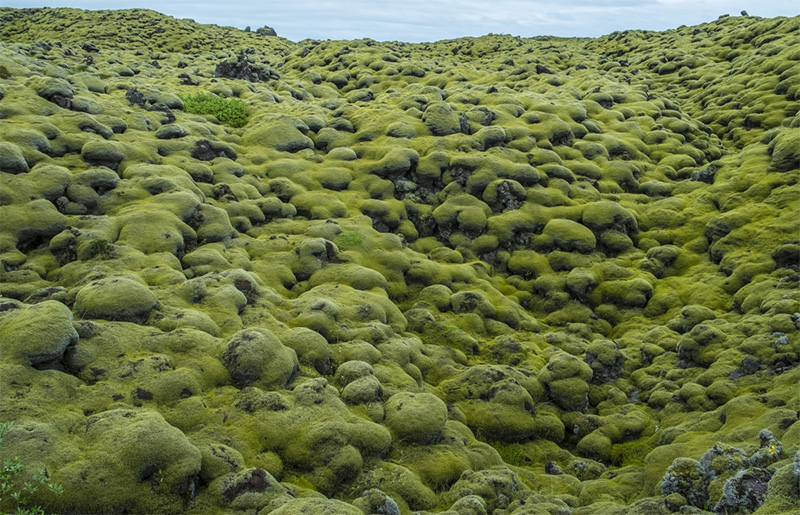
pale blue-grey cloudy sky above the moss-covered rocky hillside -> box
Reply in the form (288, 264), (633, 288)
(6, 0), (800, 42)
